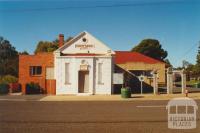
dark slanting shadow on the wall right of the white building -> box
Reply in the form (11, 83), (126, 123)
(114, 65), (153, 94)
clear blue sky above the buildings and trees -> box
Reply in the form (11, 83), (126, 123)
(0, 0), (200, 66)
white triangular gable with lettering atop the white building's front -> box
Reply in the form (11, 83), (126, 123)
(55, 31), (115, 55)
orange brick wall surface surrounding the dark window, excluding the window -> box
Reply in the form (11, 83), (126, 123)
(19, 53), (54, 94)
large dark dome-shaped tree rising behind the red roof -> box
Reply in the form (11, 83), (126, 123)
(131, 39), (168, 61)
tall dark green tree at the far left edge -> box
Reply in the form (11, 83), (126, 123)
(0, 37), (18, 76)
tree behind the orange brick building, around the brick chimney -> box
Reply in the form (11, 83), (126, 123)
(34, 37), (72, 53)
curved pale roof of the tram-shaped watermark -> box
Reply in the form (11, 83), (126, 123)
(167, 97), (198, 109)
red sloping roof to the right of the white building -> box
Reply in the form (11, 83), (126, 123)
(115, 51), (164, 64)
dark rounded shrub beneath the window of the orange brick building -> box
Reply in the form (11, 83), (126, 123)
(26, 82), (41, 94)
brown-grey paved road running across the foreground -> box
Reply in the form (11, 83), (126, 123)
(0, 100), (200, 133)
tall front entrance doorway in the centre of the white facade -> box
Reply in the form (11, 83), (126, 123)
(78, 71), (89, 93)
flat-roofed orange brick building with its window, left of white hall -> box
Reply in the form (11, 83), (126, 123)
(19, 53), (55, 94)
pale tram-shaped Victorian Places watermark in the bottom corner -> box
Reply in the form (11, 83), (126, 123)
(166, 97), (198, 129)
